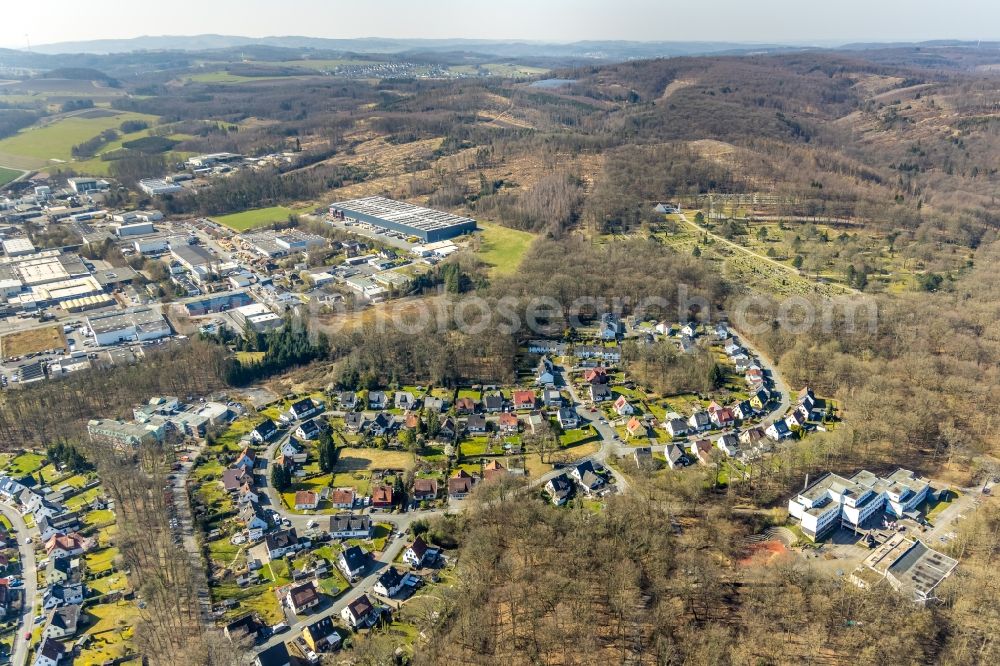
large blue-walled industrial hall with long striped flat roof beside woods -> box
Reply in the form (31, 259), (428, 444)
(330, 197), (476, 243)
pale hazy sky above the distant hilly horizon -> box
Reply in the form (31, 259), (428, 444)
(0, 0), (1000, 48)
